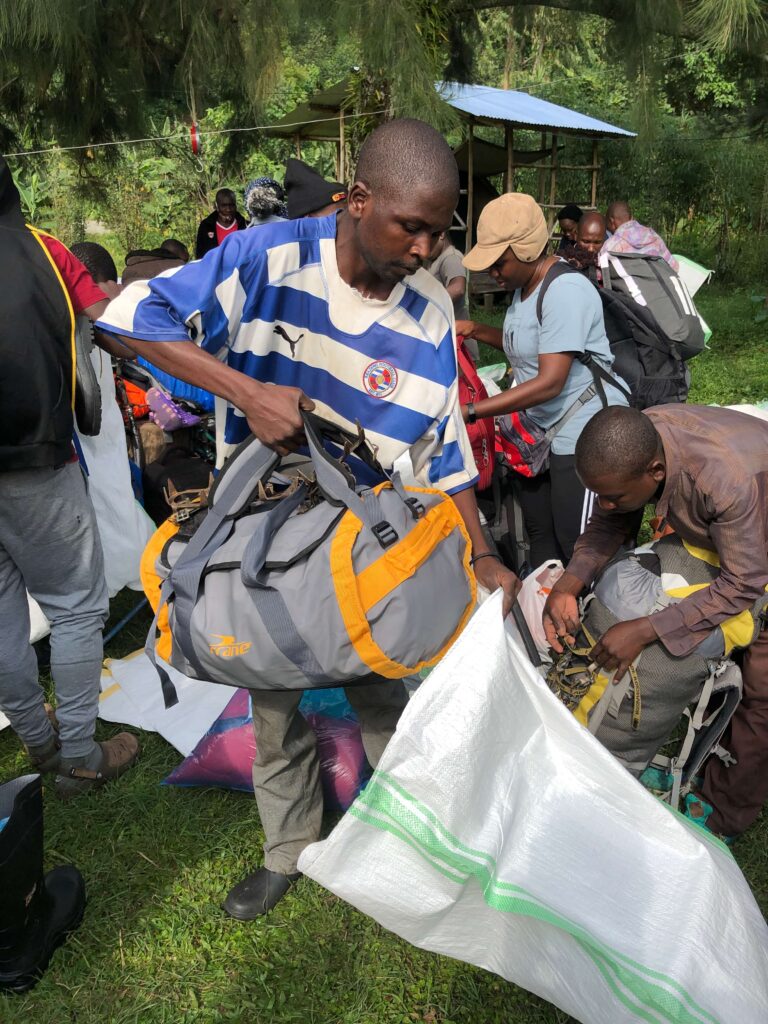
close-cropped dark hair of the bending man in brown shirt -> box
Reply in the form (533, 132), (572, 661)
(575, 406), (662, 482)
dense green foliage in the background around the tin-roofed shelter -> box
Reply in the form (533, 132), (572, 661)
(0, 0), (768, 281)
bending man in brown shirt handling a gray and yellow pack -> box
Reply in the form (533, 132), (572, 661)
(544, 406), (768, 836)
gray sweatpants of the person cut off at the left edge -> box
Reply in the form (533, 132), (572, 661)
(0, 463), (110, 758)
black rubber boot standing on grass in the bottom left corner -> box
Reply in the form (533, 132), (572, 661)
(0, 775), (85, 992)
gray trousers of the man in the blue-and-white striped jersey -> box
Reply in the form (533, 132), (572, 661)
(253, 681), (408, 874)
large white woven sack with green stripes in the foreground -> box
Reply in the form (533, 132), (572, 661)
(299, 594), (768, 1024)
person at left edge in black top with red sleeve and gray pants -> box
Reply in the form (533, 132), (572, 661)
(0, 158), (138, 800)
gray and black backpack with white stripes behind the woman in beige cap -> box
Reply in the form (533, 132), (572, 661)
(537, 253), (705, 409)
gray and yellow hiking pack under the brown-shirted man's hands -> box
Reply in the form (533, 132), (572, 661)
(547, 535), (768, 806)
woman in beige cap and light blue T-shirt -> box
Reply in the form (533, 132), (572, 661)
(456, 193), (629, 566)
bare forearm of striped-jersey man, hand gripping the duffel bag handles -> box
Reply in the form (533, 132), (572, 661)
(98, 332), (314, 455)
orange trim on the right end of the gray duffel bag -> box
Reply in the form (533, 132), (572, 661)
(331, 483), (477, 679)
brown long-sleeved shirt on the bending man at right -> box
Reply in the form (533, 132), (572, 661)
(567, 406), (768, 655)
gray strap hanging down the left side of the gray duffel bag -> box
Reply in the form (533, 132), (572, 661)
(144, 436), (280, 708)
